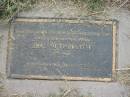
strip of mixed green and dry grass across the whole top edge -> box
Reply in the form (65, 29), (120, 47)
(0, 0), (130, 21)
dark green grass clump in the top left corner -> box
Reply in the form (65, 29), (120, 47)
(0, 0), (37, 19)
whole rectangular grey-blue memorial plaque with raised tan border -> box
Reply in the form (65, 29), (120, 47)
(7, 19), (117, 81)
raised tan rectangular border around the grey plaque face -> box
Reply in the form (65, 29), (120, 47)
(6, 18), (118, 81)
